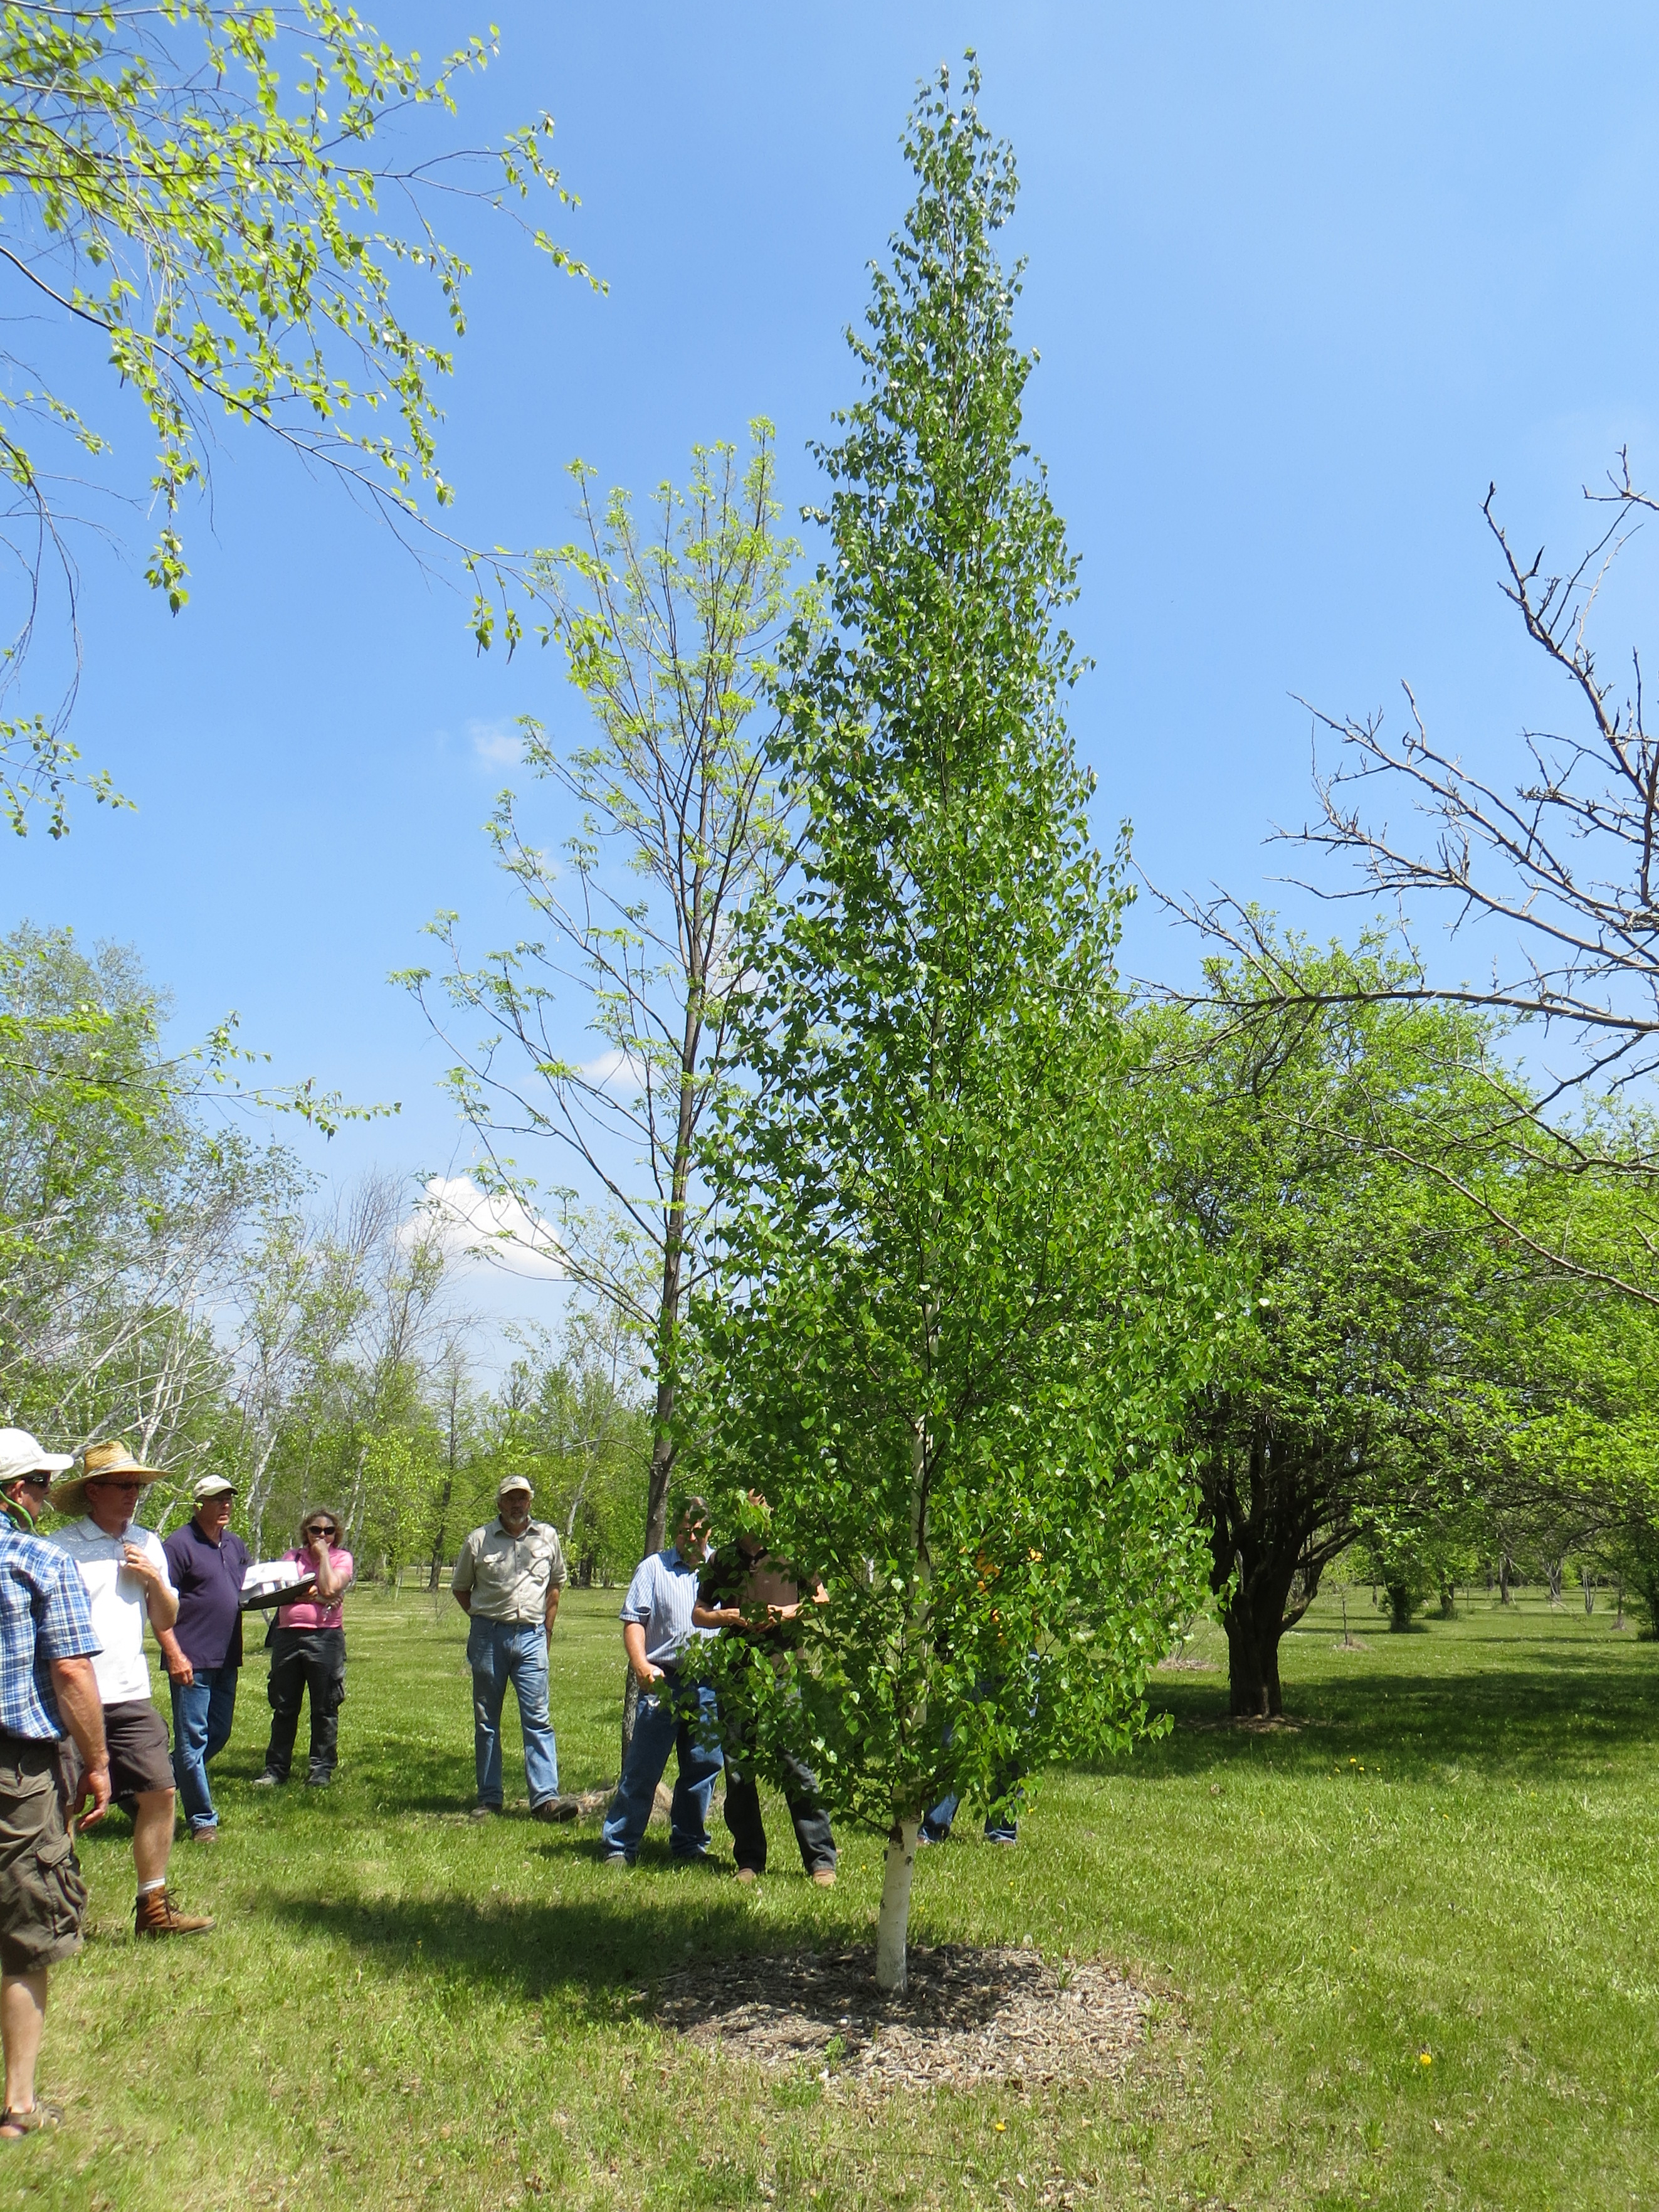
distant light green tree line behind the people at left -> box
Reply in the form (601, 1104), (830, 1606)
(0, 927), (650, 1582)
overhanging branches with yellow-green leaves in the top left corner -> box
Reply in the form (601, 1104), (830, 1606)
(0, 0), (593, 836)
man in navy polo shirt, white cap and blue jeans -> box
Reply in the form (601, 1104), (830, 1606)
(159, 1476), (248, 1843)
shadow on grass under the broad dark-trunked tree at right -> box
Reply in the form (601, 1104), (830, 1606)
(1080, 1650), (1659, 1783)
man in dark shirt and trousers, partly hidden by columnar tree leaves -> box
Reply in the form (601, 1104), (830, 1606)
(692, 1491), (836, 1889)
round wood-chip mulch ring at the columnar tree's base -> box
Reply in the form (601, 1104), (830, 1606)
(635, 1944), (1148, 2095)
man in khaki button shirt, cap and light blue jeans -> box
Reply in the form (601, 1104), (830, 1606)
(449, 1476), (575, 1821)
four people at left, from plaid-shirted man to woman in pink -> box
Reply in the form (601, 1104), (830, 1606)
(0, 1429), (352, 2139)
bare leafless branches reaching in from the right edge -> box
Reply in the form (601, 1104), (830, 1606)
(1166, 453), (1659, 1303)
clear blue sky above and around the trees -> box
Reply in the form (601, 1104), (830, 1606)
(0, 0), (1659, 1327)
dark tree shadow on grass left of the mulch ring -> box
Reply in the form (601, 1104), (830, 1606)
(265, 1867), (831, 2019)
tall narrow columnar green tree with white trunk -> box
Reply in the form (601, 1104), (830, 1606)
(686, 66), (1208, 1989)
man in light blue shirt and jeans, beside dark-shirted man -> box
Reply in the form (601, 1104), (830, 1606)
(604, 1498), (721, 1867)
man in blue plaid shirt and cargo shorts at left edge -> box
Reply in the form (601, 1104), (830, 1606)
(0, 1429), (108, 2139)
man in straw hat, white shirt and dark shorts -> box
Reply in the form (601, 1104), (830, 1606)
(51, 1442), (213, 1935)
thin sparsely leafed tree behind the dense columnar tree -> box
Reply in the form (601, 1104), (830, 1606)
(403, 423), (809, 1550)
